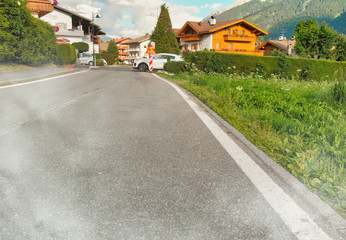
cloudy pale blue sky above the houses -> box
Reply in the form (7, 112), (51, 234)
(58, 0), (236, 38)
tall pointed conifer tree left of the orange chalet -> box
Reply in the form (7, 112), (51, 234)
(150, 4), (180, 54)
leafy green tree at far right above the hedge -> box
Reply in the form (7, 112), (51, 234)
(294, 19), (346, 60)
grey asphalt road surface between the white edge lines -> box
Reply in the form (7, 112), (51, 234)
(0, 67), (344, 240)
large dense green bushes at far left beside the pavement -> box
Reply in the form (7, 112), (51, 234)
(0, 0), (56, 65)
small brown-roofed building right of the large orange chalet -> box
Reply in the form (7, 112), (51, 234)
(256, 38), (298, 57)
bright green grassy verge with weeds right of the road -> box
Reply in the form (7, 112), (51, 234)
(159, 73), (346, 218)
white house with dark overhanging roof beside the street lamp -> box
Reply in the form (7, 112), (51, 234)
(41, 6), (105, 53)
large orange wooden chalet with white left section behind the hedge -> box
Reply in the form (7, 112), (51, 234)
(177, 18), (268, 56)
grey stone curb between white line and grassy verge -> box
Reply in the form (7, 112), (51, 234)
(154, 74), (346, 239)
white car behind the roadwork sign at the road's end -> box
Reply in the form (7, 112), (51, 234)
(132, 53), (184, 72)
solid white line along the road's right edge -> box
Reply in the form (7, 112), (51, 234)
(154, 74), (332, 240)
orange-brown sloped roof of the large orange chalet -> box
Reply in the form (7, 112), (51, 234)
(177, 19), (269, 35)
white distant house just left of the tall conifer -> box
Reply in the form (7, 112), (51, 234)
(125, 34), (150, 62)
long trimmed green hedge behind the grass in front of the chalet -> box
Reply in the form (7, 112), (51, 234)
(184, 51), (346, 81)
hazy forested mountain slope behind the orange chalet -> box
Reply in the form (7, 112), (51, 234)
(205, 0), (346, 39)
